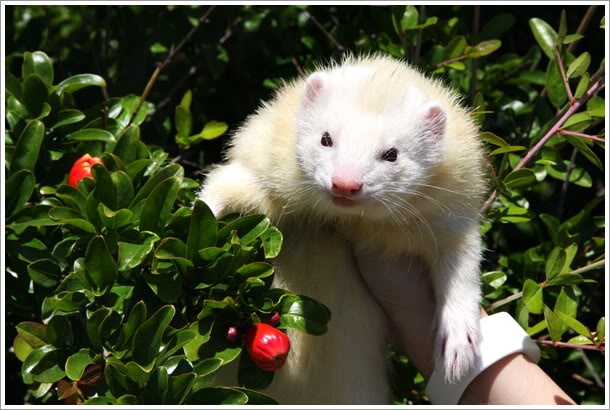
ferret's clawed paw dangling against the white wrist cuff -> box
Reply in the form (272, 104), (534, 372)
(435, 316), (481, 383)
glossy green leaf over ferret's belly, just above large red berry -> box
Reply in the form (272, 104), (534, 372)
(275, 294), (331, 335)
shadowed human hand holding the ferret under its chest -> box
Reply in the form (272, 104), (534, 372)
(355, 251), (435, 378)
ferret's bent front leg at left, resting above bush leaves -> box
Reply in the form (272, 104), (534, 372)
(199, 163), (266, 218)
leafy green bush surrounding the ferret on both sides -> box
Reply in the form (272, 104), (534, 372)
(4, 5), (606, 404)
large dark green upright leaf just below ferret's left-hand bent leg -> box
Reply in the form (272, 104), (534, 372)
(186, 199), (218, 260)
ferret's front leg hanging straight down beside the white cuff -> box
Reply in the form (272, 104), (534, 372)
(432, 232), (481, 381)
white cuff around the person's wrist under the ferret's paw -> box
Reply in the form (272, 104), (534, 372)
(426, 312), (540, 404)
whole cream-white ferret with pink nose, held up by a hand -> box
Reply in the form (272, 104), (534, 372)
(201, 55), (486, 404)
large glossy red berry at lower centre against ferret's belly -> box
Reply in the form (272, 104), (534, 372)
(244, 323), (290, 372)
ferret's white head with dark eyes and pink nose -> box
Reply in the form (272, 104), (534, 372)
(296, 66), (447, 223)
